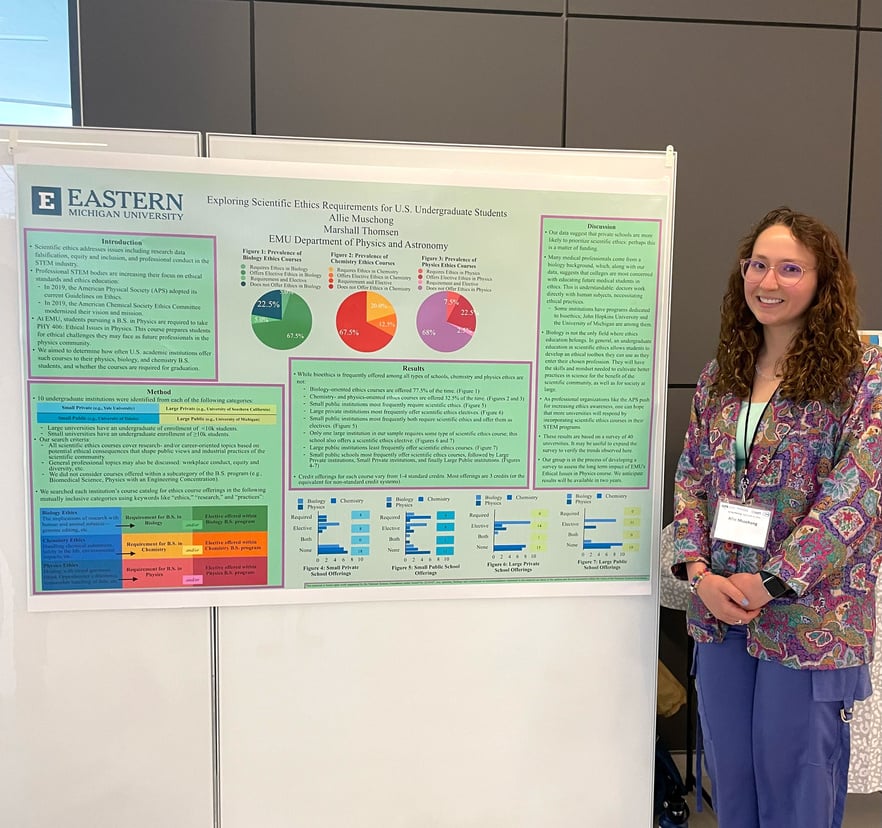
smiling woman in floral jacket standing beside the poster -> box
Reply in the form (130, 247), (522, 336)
(673, 208), (882, 828)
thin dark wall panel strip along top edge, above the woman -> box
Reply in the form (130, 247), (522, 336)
(569, 0), (867, 26)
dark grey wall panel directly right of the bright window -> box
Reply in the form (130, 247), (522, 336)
(80, 0), (251, 133)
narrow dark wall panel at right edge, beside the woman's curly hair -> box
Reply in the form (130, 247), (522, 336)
(848, 32), (882, 330)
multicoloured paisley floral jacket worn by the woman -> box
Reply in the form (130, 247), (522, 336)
(672, 347), (882, 669)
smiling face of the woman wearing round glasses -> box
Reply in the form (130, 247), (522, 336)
(744, 224), (818, 334)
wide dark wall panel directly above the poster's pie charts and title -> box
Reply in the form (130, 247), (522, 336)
(255, 3), (564, 146)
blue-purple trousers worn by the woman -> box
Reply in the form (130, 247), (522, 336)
(695, 627), (853, 828)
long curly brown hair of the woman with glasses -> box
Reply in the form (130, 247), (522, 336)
(714, 207), (863, 402)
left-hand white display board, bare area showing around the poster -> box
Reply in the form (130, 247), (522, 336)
(0, 127), (214, 828)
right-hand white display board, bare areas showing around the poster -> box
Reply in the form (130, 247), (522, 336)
(209, 136), (673, 828)
